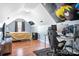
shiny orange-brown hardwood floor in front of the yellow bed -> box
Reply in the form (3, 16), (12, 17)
(10, 40), (48, 56)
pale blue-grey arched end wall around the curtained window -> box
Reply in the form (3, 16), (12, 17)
(7, 19), (31, 33)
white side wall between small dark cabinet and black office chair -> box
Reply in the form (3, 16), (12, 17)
(33, 25), (50, 43)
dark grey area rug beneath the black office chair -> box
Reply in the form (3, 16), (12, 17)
(33, 48), (79, 56)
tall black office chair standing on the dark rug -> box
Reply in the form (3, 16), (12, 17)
(47, 25), (66, 55)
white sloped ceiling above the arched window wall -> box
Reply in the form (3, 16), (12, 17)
(0, 3), (56, 25)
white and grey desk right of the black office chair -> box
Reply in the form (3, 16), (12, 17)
(57, 36), (79, 54)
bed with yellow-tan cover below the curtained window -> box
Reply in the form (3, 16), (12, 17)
(10, 32), (32, 41)
